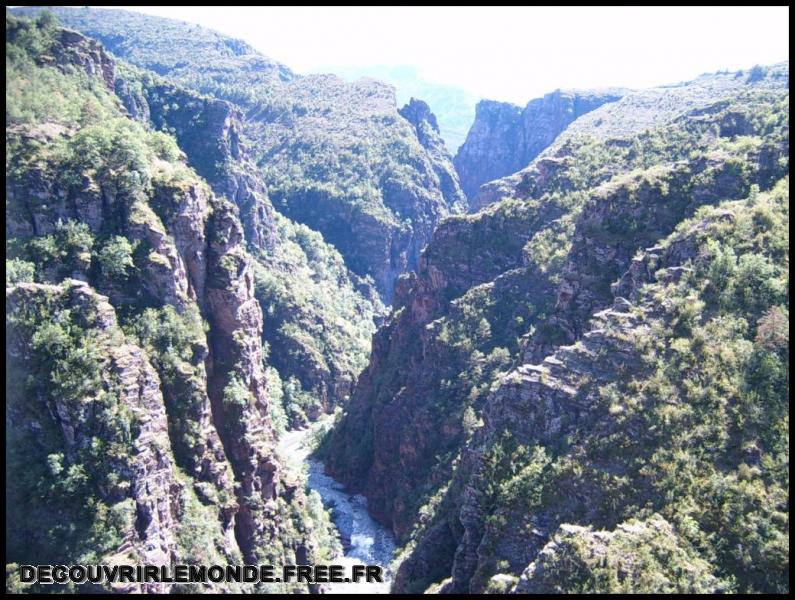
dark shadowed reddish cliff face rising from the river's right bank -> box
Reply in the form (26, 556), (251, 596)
(326, 200), (533, 536)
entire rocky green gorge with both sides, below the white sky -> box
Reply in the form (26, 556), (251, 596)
(6, 7), (789, 594)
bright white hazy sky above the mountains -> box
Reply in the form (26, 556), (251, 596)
(112, 7), (789, 104)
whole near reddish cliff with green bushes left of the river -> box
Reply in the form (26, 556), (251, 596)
(6, 18), (336, 591)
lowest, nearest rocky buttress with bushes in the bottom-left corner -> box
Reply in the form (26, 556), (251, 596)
(6, 280), (190, 592)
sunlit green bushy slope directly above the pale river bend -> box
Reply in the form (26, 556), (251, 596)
(255, 214), (384, 426)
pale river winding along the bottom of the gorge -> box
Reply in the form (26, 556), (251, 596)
(278, 423), (395, 594)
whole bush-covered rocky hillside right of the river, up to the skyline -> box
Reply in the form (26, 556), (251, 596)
(323, 58), (789, 592)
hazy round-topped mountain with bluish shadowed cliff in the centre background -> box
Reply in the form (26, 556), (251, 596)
(248, 75), (461, 303)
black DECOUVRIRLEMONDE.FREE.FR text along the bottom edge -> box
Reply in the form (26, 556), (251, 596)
(19, 565), (383, 584)
